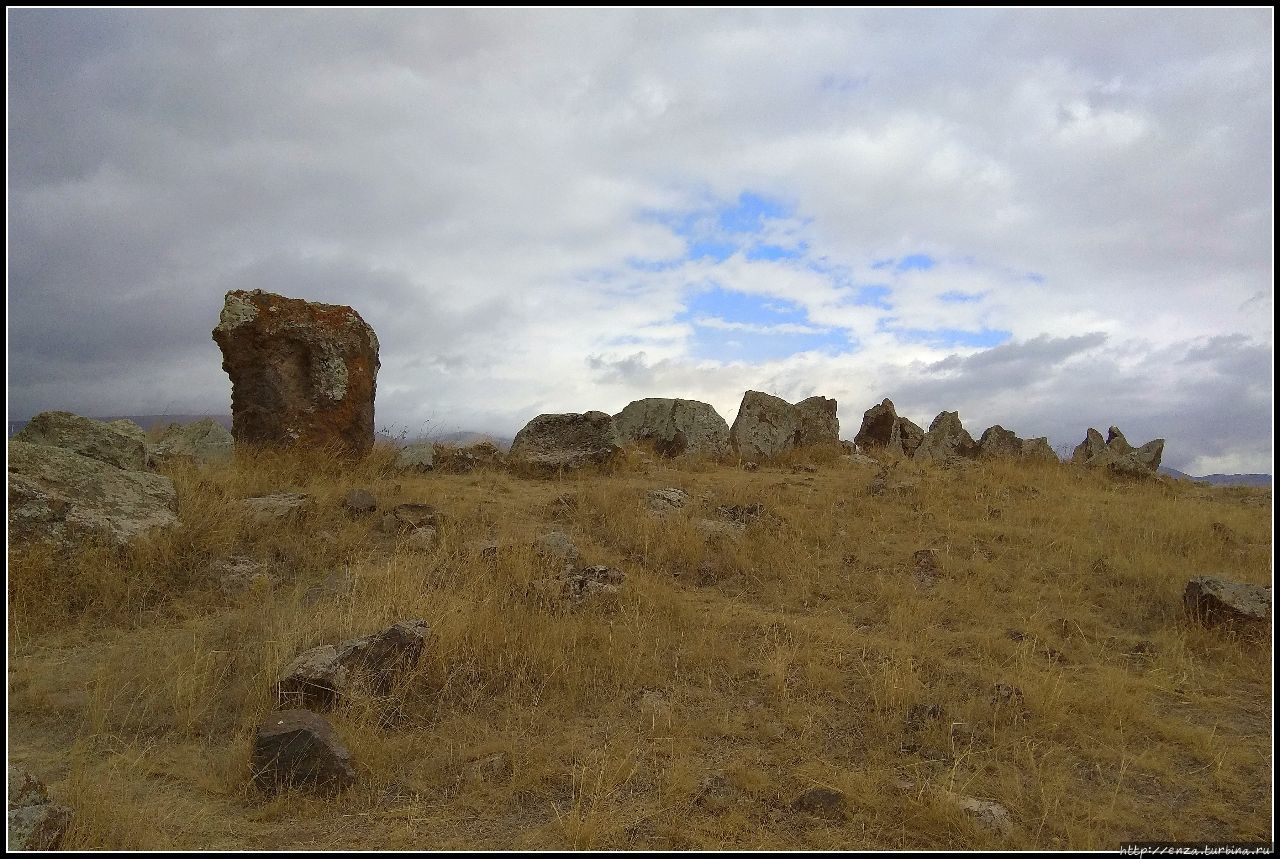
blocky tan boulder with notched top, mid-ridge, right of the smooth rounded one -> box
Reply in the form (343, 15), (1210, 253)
(728, 390), (840, 460)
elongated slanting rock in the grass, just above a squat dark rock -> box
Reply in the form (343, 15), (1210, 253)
(275, 620), (430, 709)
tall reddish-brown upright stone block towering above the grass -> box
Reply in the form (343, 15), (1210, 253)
(214, 289), (379, 456)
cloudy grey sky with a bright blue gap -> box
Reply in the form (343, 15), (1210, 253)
(8, 9), (1274, 474)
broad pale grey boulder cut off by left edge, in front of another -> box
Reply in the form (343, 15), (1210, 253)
(9, 442), (178, 547)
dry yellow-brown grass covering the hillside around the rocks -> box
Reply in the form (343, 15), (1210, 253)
(9, 449), (1274, 849)
